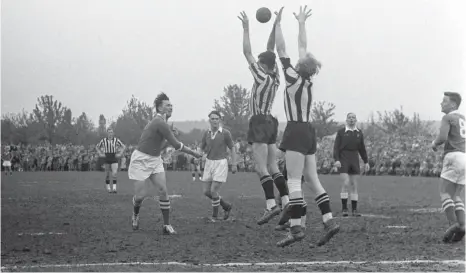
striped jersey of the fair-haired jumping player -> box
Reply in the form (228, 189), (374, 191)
(280, 58), (312, 122)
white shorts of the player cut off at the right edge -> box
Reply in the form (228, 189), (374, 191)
(440, 152), (466, 185)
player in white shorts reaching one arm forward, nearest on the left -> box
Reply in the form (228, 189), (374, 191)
(128, 93), (201, 235)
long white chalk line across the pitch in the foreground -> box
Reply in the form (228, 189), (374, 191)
(1, 260), (465, 270)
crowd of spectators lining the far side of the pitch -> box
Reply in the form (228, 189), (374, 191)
(2, 131), (442, 177)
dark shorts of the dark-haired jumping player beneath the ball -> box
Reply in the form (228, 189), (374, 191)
(248, 115), (278, 144)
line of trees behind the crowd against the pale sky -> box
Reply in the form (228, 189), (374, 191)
(1, 84), (434, 145)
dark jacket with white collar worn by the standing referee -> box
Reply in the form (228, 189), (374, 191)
(333, 126), (368, 164)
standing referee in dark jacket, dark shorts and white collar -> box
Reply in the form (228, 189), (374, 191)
(333, 113), (370, 217)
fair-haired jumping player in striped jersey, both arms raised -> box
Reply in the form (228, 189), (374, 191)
(275, 6), (340, 247)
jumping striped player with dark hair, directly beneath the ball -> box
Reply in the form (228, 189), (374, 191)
(238, 9), (289, 225)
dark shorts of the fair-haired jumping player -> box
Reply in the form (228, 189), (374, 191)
(280, 121), (317, 155)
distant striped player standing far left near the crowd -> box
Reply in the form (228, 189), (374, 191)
(96, 128), (126, 193)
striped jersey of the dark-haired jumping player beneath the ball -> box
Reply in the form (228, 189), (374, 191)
(249, 63), (280, 115)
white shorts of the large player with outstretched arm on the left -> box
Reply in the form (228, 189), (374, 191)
(128, 150), (165, 181)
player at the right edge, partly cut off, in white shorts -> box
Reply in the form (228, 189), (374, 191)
(432, 92), (466, 243)
